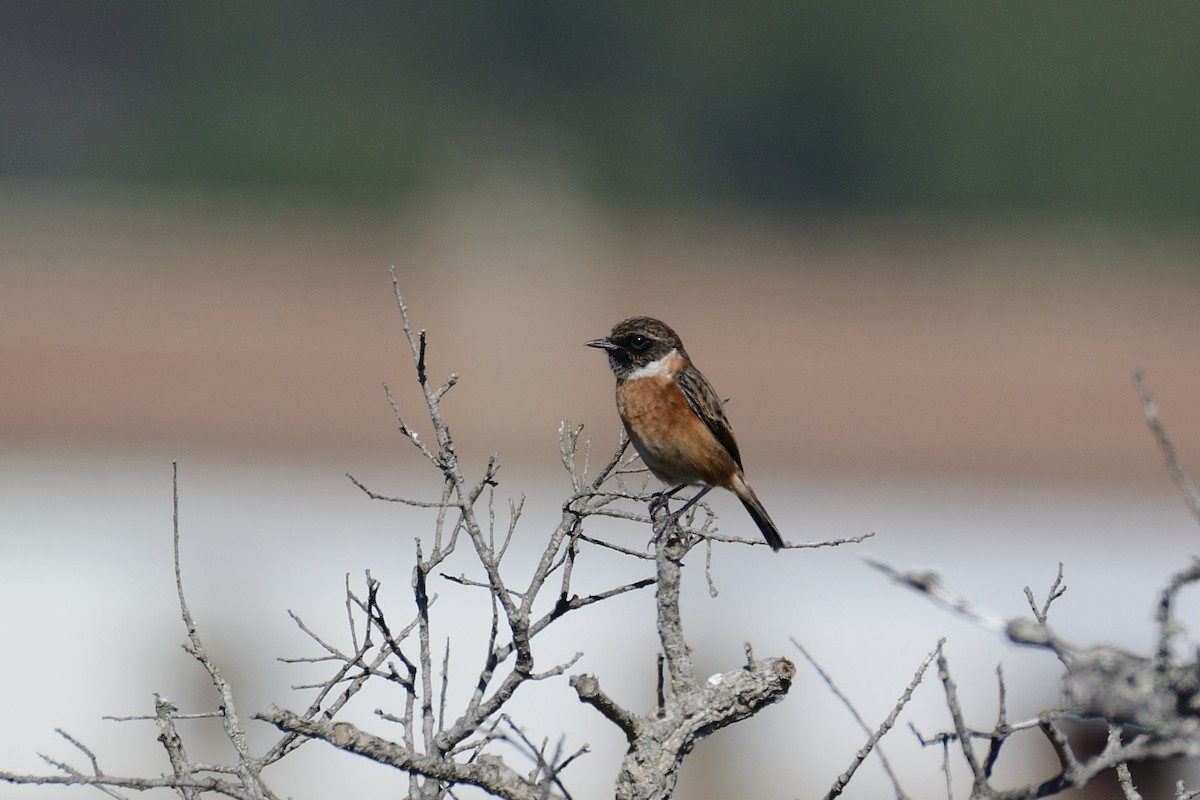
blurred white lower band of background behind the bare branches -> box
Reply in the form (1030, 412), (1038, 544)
(0, 451), (1196, 799)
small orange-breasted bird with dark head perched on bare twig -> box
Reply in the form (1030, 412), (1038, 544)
(584, 317), (784, 551)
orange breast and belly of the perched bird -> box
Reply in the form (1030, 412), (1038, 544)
(617, 353), (738, 487)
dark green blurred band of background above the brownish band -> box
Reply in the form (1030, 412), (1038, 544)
(9, 0), (1200, 223)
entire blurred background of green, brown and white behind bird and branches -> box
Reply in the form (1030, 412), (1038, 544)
(0, 1), (1200, 798)
